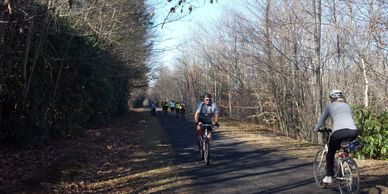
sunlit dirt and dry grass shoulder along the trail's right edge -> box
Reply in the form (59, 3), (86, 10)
(220, 121), (388, 193)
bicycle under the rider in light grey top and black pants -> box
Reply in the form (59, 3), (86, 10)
(313, 128), (362, 193)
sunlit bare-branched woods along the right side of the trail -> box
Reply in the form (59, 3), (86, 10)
(153, 0), (388, 158)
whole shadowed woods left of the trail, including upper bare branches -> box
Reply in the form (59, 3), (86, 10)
(0, 0), (151, 145)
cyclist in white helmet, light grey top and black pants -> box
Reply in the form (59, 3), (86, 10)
(313, 90), (358, 183)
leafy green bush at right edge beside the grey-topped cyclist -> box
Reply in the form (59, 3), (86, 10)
(354, 107), (388, 159)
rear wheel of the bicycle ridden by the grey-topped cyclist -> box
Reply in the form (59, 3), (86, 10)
(339, 158), (360, 193)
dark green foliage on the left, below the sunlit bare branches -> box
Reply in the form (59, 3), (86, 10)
(0, 1), (148, 145)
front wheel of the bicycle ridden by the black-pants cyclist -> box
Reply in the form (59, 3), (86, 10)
(313, 149), (327, 188)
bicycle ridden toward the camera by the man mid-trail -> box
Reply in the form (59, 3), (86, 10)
(199, 124), (214, 166)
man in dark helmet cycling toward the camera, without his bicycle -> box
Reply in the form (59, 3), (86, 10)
(194, 93), (219, 143)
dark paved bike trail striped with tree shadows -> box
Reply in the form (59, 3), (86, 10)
(158, 113), (339, 194)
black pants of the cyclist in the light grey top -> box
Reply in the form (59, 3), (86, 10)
(326, 129), (358, 176)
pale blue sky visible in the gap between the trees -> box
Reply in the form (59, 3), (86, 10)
(148, 0), (241, 68)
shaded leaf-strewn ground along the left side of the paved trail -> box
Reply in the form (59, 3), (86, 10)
(0, 110), (189, 193)
